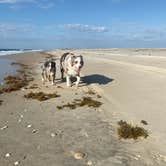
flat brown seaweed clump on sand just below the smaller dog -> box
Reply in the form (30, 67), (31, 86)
(24, 92), (60, 101)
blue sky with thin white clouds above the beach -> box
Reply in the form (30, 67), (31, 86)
(0, 0), (166, 49)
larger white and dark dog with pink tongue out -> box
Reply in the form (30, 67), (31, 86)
(60, 53), (84, 86)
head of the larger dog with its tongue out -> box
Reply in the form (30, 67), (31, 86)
(71, 55), (84, 72)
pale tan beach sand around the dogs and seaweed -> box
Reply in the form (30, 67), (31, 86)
(0, 49), (166, 166)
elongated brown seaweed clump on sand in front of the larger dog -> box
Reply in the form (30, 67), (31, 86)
(57, 97), (102, 109)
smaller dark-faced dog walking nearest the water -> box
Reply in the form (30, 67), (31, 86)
(42, 61), (56, 85)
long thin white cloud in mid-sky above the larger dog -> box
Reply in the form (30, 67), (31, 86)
(61, 24), (109, 33)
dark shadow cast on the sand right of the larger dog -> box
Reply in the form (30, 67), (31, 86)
(82, 74), (114, 85)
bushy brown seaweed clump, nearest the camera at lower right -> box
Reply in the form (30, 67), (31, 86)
(118, 120), (149, 139)
